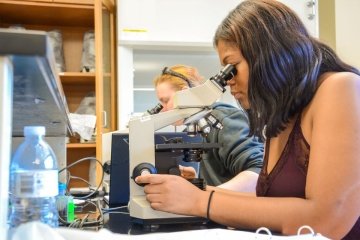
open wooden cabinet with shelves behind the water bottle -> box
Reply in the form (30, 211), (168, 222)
(0, 0), (116, 187)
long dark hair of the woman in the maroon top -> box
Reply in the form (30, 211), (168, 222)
(214, 0), (360, 140)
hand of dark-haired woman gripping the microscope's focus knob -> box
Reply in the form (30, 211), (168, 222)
(135, 174), (209, 217)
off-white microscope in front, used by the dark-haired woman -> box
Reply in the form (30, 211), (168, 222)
(129, 64), (236, 224)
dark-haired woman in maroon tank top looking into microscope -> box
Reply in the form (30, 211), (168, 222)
(136, 0), (360, 240)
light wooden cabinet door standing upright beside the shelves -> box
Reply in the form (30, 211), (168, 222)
(95, 0), (116, 183)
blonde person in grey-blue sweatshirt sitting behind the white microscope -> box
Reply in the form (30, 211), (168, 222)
(154, 65), (263, 192)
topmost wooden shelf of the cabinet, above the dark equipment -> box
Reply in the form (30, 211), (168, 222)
(0, 0), (94, 28)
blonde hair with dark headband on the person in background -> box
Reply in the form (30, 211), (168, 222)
(154, 64), (204, 91)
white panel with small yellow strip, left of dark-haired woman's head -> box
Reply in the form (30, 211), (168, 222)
(118, 0), (240, 46)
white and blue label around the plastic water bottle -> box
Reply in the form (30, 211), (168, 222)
(15, 170), (59, 198)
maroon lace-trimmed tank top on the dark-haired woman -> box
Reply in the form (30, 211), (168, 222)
(256, 114), (360, 240)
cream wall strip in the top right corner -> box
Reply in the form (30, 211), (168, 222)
(335, 0), (360, 69)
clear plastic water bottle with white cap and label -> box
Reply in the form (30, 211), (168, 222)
(9, 126), (58, 229)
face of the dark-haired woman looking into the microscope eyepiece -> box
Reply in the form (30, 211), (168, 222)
(217, 41), (250, 109)
